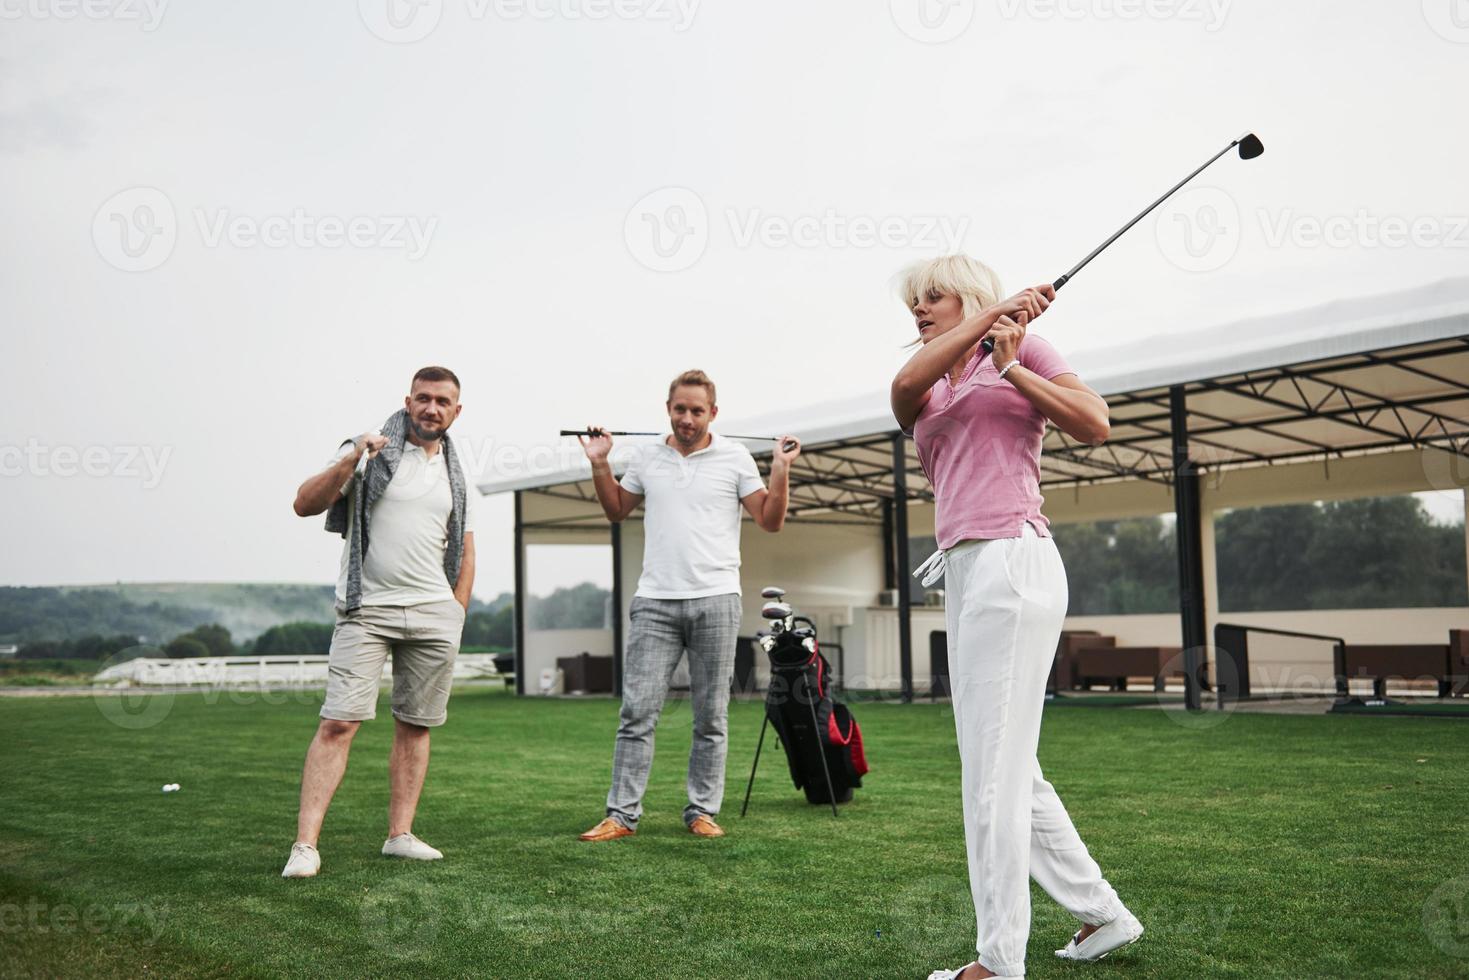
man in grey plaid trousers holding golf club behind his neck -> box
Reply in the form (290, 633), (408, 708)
(579, 370), (801, 840)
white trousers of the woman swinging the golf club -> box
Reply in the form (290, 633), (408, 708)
(940, 523), (1124, 976)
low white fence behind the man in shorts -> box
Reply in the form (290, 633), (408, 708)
(93, 654), (508, 688)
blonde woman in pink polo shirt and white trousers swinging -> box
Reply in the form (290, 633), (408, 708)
(892, 256), (1143, 980)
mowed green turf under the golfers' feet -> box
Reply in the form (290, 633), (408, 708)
(0, 691), (1469, 979)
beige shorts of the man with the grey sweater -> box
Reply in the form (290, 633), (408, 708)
(322, 599), (464, 727)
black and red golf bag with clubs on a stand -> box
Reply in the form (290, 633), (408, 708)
(739, 586), (867, 817)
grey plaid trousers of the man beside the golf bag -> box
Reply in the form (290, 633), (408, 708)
(607, 594), (740, 830)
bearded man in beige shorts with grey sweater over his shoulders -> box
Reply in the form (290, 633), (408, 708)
(282, 367), (479, 879)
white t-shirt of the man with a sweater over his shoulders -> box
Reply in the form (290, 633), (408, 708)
(332, 441), (479, 605)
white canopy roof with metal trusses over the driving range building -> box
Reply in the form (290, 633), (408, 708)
(480, 278), (1469, 502)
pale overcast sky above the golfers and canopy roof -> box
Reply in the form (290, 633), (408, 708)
(0, 0), (1469, 597)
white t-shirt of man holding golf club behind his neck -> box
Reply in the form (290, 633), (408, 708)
(621, 435), (765, 599)
